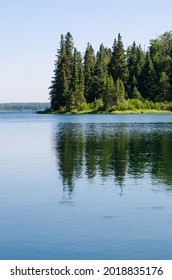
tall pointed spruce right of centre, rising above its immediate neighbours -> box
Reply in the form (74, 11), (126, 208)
(109, 34), (128, 85)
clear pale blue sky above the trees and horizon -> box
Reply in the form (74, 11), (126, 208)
(0, 0), (172, 103)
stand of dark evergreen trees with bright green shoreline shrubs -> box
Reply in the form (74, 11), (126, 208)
(49, 31), (172, 113)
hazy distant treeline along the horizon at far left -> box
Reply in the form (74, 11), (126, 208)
(0, 102), (50, 112)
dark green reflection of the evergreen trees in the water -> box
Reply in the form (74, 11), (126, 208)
(55, 124), (172, 191)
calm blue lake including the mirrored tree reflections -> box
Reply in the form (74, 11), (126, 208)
(0, 113), (172, 260)
